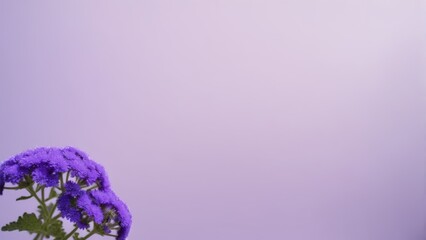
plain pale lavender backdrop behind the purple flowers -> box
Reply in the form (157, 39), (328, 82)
(0, 0), (426, 240)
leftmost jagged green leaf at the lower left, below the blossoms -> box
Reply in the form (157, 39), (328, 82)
(1, 213), (42, 233)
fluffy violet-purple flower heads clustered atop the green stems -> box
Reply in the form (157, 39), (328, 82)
(0, 147), (132, 240)
